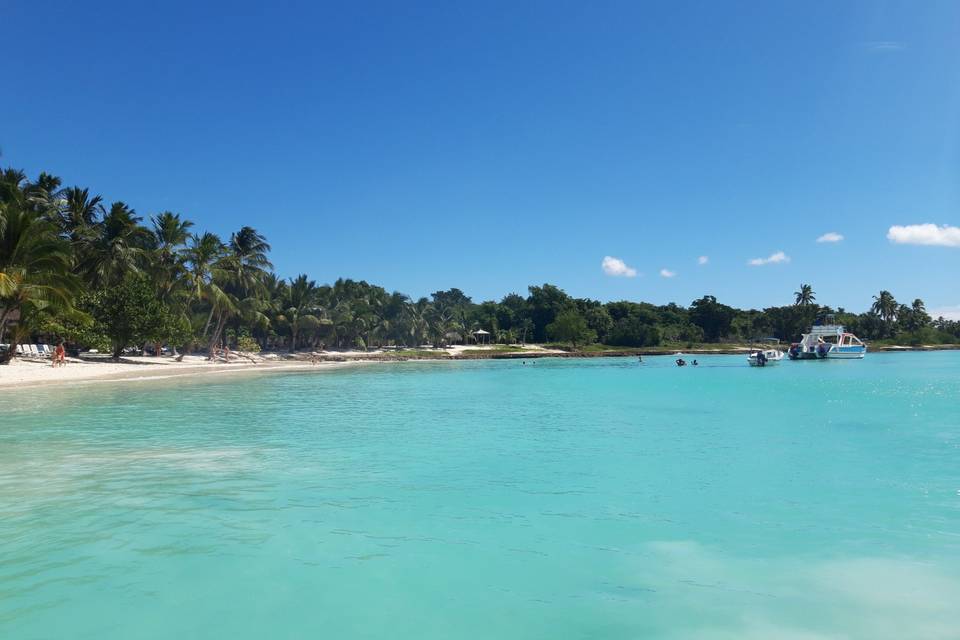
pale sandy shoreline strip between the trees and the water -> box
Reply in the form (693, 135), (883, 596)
(0, 344), (960, 391)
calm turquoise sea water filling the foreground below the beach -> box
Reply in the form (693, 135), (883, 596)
(0, 352), (960, 640)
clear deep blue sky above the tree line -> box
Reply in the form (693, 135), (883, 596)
(0, 0), (960, 314)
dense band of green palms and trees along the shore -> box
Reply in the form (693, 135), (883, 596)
(0, 169), (960, 361)
